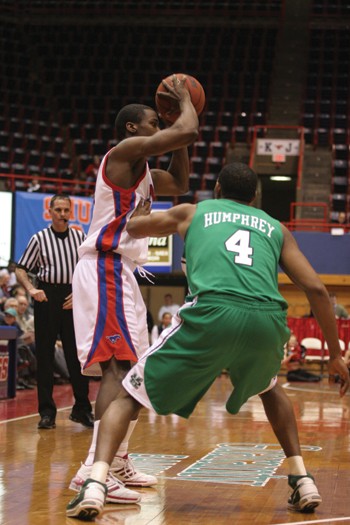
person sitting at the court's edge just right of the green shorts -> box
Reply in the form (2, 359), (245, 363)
(282, 334), (321, 383)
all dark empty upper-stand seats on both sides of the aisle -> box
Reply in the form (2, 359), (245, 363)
(0, 0), (350, 217)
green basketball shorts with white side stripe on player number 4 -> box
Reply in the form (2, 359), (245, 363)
(123, 296), (289, 418)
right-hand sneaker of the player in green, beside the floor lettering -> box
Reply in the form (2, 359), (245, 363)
(288, 474), (322, 512)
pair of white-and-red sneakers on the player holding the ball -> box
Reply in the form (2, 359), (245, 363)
(69, 463), (141, 504)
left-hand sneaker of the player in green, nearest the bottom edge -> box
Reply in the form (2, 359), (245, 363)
(66, 479), (107, 521)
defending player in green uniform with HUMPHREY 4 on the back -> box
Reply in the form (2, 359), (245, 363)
(67, 163), (349, 519)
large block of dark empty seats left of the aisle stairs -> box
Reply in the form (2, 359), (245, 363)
(0, 10), (281, 200)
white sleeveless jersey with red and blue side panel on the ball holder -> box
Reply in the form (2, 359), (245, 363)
(78, 150), (154, 265)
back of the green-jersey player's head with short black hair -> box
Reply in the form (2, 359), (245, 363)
(218, 162), (258, 203)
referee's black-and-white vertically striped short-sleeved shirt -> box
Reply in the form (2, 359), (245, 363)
(17, 227), (85, 284)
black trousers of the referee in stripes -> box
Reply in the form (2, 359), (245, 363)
(34, 282), (92, 417)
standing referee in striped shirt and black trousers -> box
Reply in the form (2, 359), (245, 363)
(16, 195), (94, 429)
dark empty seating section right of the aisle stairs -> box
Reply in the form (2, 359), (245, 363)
(300, 21), (350, 219)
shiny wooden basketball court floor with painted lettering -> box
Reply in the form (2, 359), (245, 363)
(0, 375), (350, 525)
